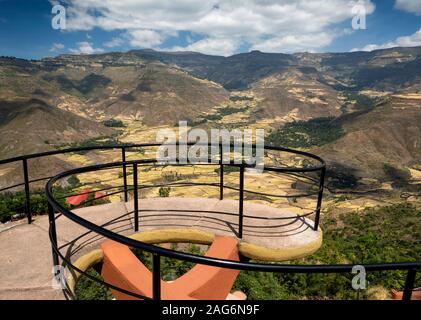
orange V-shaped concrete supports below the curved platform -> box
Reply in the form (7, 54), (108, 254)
(101, 237), (239, 300)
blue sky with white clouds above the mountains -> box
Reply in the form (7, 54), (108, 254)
(0, 0), (421, 59)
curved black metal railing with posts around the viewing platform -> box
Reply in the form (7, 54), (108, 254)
(0, 144), (421, 300)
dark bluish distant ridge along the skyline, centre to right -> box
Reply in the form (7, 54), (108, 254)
(123, 47), (421, 90)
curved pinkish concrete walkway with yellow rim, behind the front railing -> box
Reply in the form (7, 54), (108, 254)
(75, 197), (322, 261)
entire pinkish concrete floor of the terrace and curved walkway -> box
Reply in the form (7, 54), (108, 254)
(0, 198), (321, 299)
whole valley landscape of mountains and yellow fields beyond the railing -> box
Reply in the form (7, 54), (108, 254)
(0, 48), (421, 215)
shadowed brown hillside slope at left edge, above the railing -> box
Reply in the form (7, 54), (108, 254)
(0, 99), (114, 159)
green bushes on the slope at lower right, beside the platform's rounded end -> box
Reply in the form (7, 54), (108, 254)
(235, 203), (421, 300)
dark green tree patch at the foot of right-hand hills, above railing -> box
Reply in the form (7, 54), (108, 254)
(267, 117), (345, 148)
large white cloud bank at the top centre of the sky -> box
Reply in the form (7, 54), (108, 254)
(60, 0), (375, 54)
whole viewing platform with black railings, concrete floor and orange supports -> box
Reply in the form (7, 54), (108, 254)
(0, 144), (420, 300)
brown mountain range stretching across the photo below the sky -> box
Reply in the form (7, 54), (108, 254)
(0, 47), (421, 189)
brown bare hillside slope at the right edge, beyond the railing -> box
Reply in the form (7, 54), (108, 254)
(313, 98), (421, 178)
